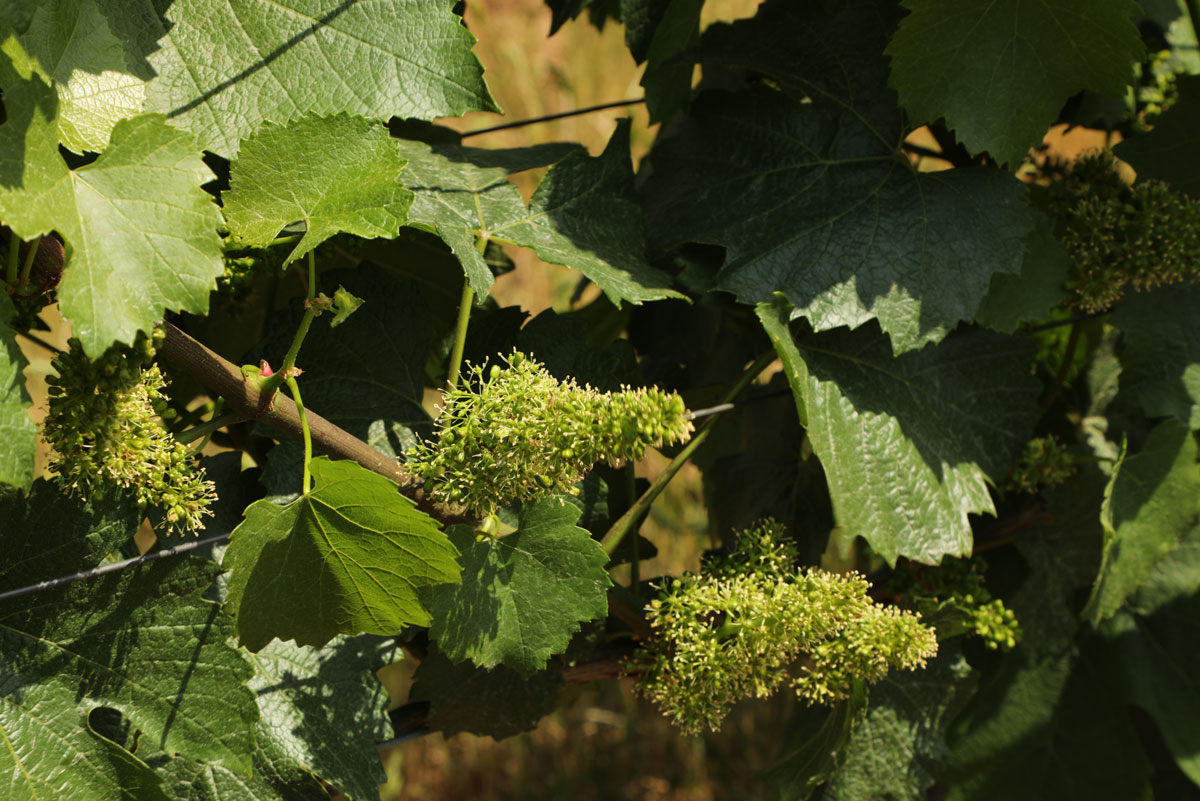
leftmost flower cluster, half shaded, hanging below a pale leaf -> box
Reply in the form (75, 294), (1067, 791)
(43, 331), (216, 531)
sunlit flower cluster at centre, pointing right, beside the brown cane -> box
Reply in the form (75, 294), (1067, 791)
(404, 351), (692, 516)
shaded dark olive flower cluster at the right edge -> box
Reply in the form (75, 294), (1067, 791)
(1042, 152), (1200, 312)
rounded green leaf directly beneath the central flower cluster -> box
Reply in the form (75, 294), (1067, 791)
(425, 499), (612, 677)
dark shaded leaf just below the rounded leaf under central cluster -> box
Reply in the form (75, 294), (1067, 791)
(409, 649), (563, 740)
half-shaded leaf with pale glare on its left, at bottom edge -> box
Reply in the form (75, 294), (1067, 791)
(247, 637), (398, 799)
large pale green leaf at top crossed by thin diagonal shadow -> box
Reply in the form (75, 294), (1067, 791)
(146, 0), (499, 158)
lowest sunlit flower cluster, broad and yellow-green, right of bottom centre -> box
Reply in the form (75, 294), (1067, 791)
(628, 520), (937, 734)
